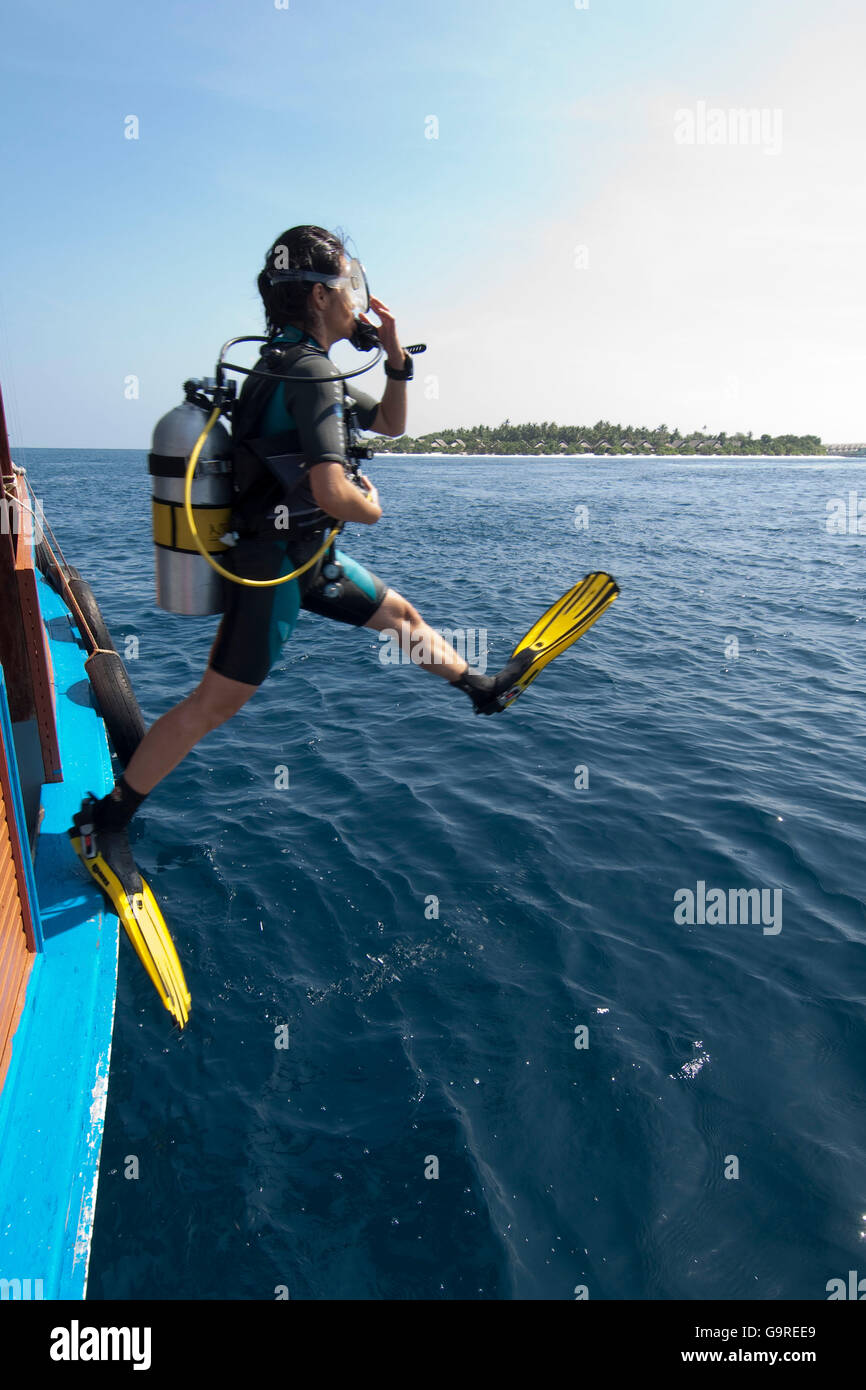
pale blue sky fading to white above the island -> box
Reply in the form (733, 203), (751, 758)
(0, 0), (866, 449)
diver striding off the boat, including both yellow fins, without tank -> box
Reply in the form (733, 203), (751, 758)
(70, 225), (619, 1026)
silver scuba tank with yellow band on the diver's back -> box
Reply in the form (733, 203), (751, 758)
(147, 381), (232, 617)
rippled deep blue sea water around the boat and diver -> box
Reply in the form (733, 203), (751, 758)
(18, 450), (866, 1300)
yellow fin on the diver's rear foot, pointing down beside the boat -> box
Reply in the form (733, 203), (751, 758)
(70, 798), (190, 1027)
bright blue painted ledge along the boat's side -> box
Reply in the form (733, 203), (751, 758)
(0, 577), (118, 1298)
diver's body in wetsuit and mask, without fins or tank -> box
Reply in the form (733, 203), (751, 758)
(93, 227), (528, 811)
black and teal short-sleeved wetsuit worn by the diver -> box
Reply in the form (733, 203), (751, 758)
(210, 328), (386, 685)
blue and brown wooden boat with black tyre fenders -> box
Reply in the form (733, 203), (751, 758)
(0, 380), (143, 1300)
